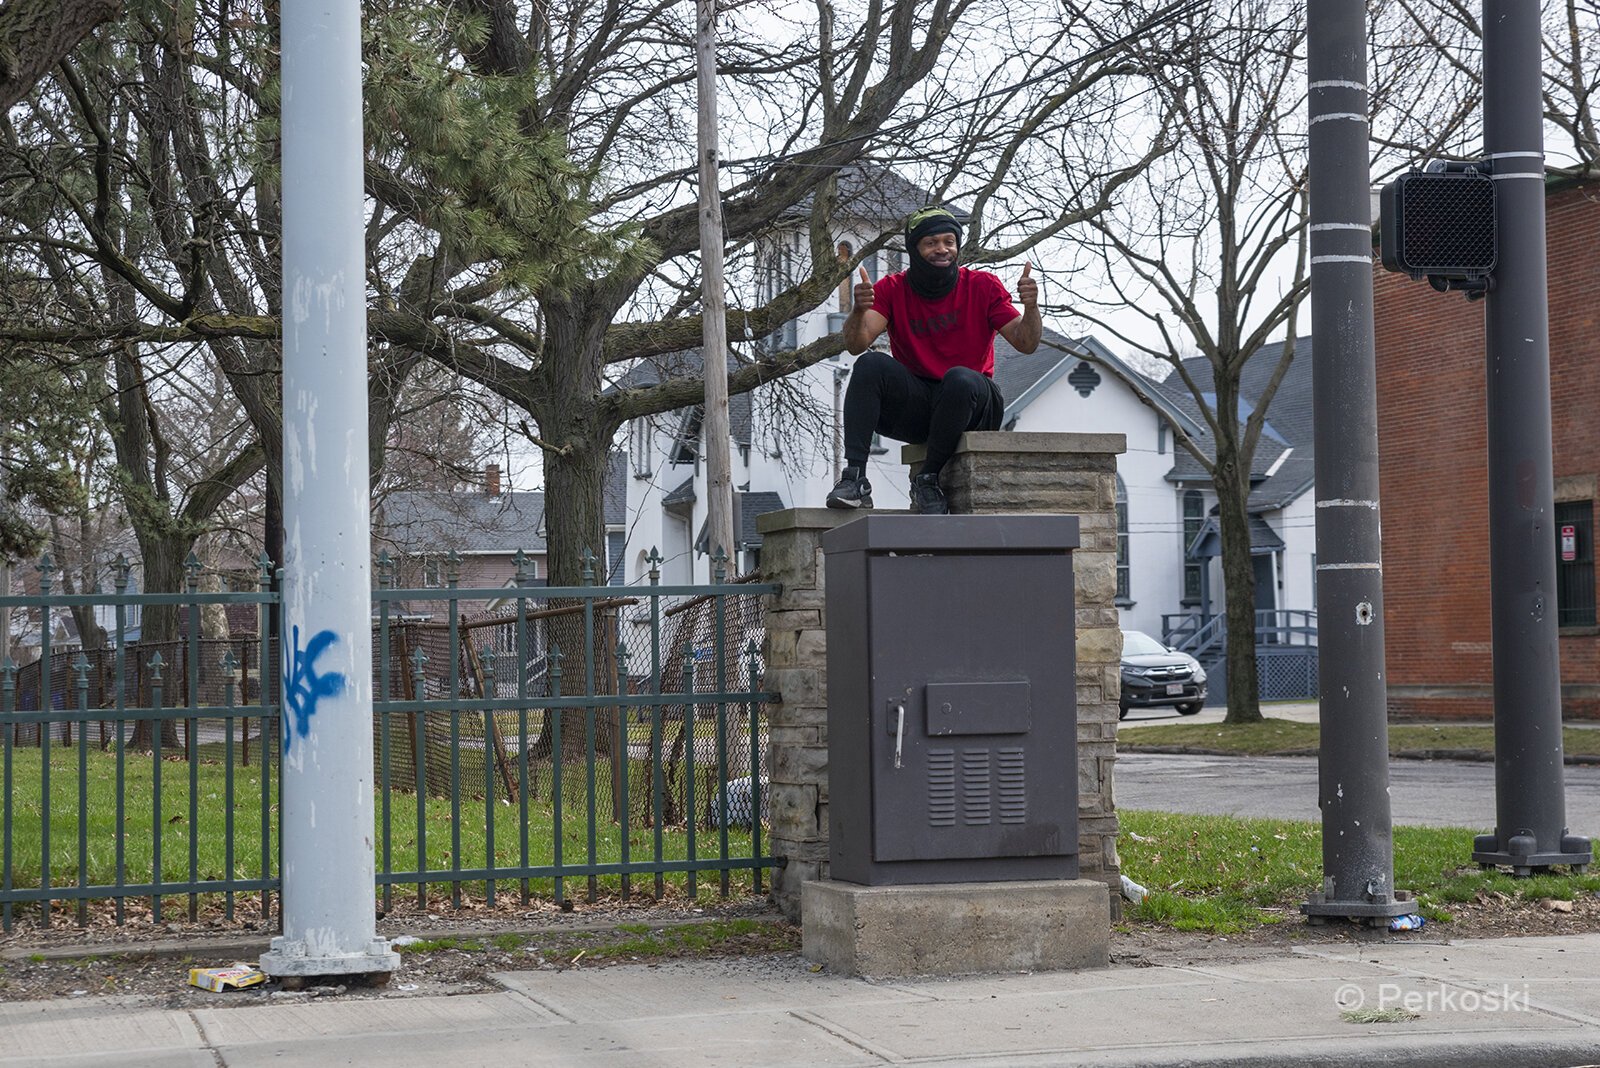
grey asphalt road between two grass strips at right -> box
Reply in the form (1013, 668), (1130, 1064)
(1115, 751), (1600, 838)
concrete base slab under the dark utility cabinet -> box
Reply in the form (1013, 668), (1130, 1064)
(800, 879), (1110, 978)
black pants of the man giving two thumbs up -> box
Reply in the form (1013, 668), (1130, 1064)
(845, 352), (1005, 475)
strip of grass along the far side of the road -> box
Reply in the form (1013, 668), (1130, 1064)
(1117, 718), (1600, 759)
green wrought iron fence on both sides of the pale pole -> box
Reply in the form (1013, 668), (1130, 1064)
(0, 546), (776, 929)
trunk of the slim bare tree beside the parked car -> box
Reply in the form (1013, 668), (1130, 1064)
(1214, 435), (1261, 723)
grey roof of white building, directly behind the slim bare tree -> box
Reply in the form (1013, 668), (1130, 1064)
(1160, 337), (1317, 512)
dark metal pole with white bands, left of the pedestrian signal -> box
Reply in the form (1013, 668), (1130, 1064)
(1301, 0), (1413, 923)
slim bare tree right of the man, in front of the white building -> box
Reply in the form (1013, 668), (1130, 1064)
(1078, 0), (1307, 723)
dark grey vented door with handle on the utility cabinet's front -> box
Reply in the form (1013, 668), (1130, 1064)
(862, 552), (1078, 863)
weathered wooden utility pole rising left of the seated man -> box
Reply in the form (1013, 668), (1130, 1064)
(694, 0), (738, 571)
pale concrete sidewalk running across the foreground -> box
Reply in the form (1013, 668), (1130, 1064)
(12, 935), (1600, 1068)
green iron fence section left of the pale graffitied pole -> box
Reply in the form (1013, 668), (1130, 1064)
(0, 558), (278, 931)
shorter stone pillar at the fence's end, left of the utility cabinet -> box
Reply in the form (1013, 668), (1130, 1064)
(755, 508), (861, 923)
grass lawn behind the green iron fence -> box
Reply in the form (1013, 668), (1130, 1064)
(6, 748), (765, 920)
